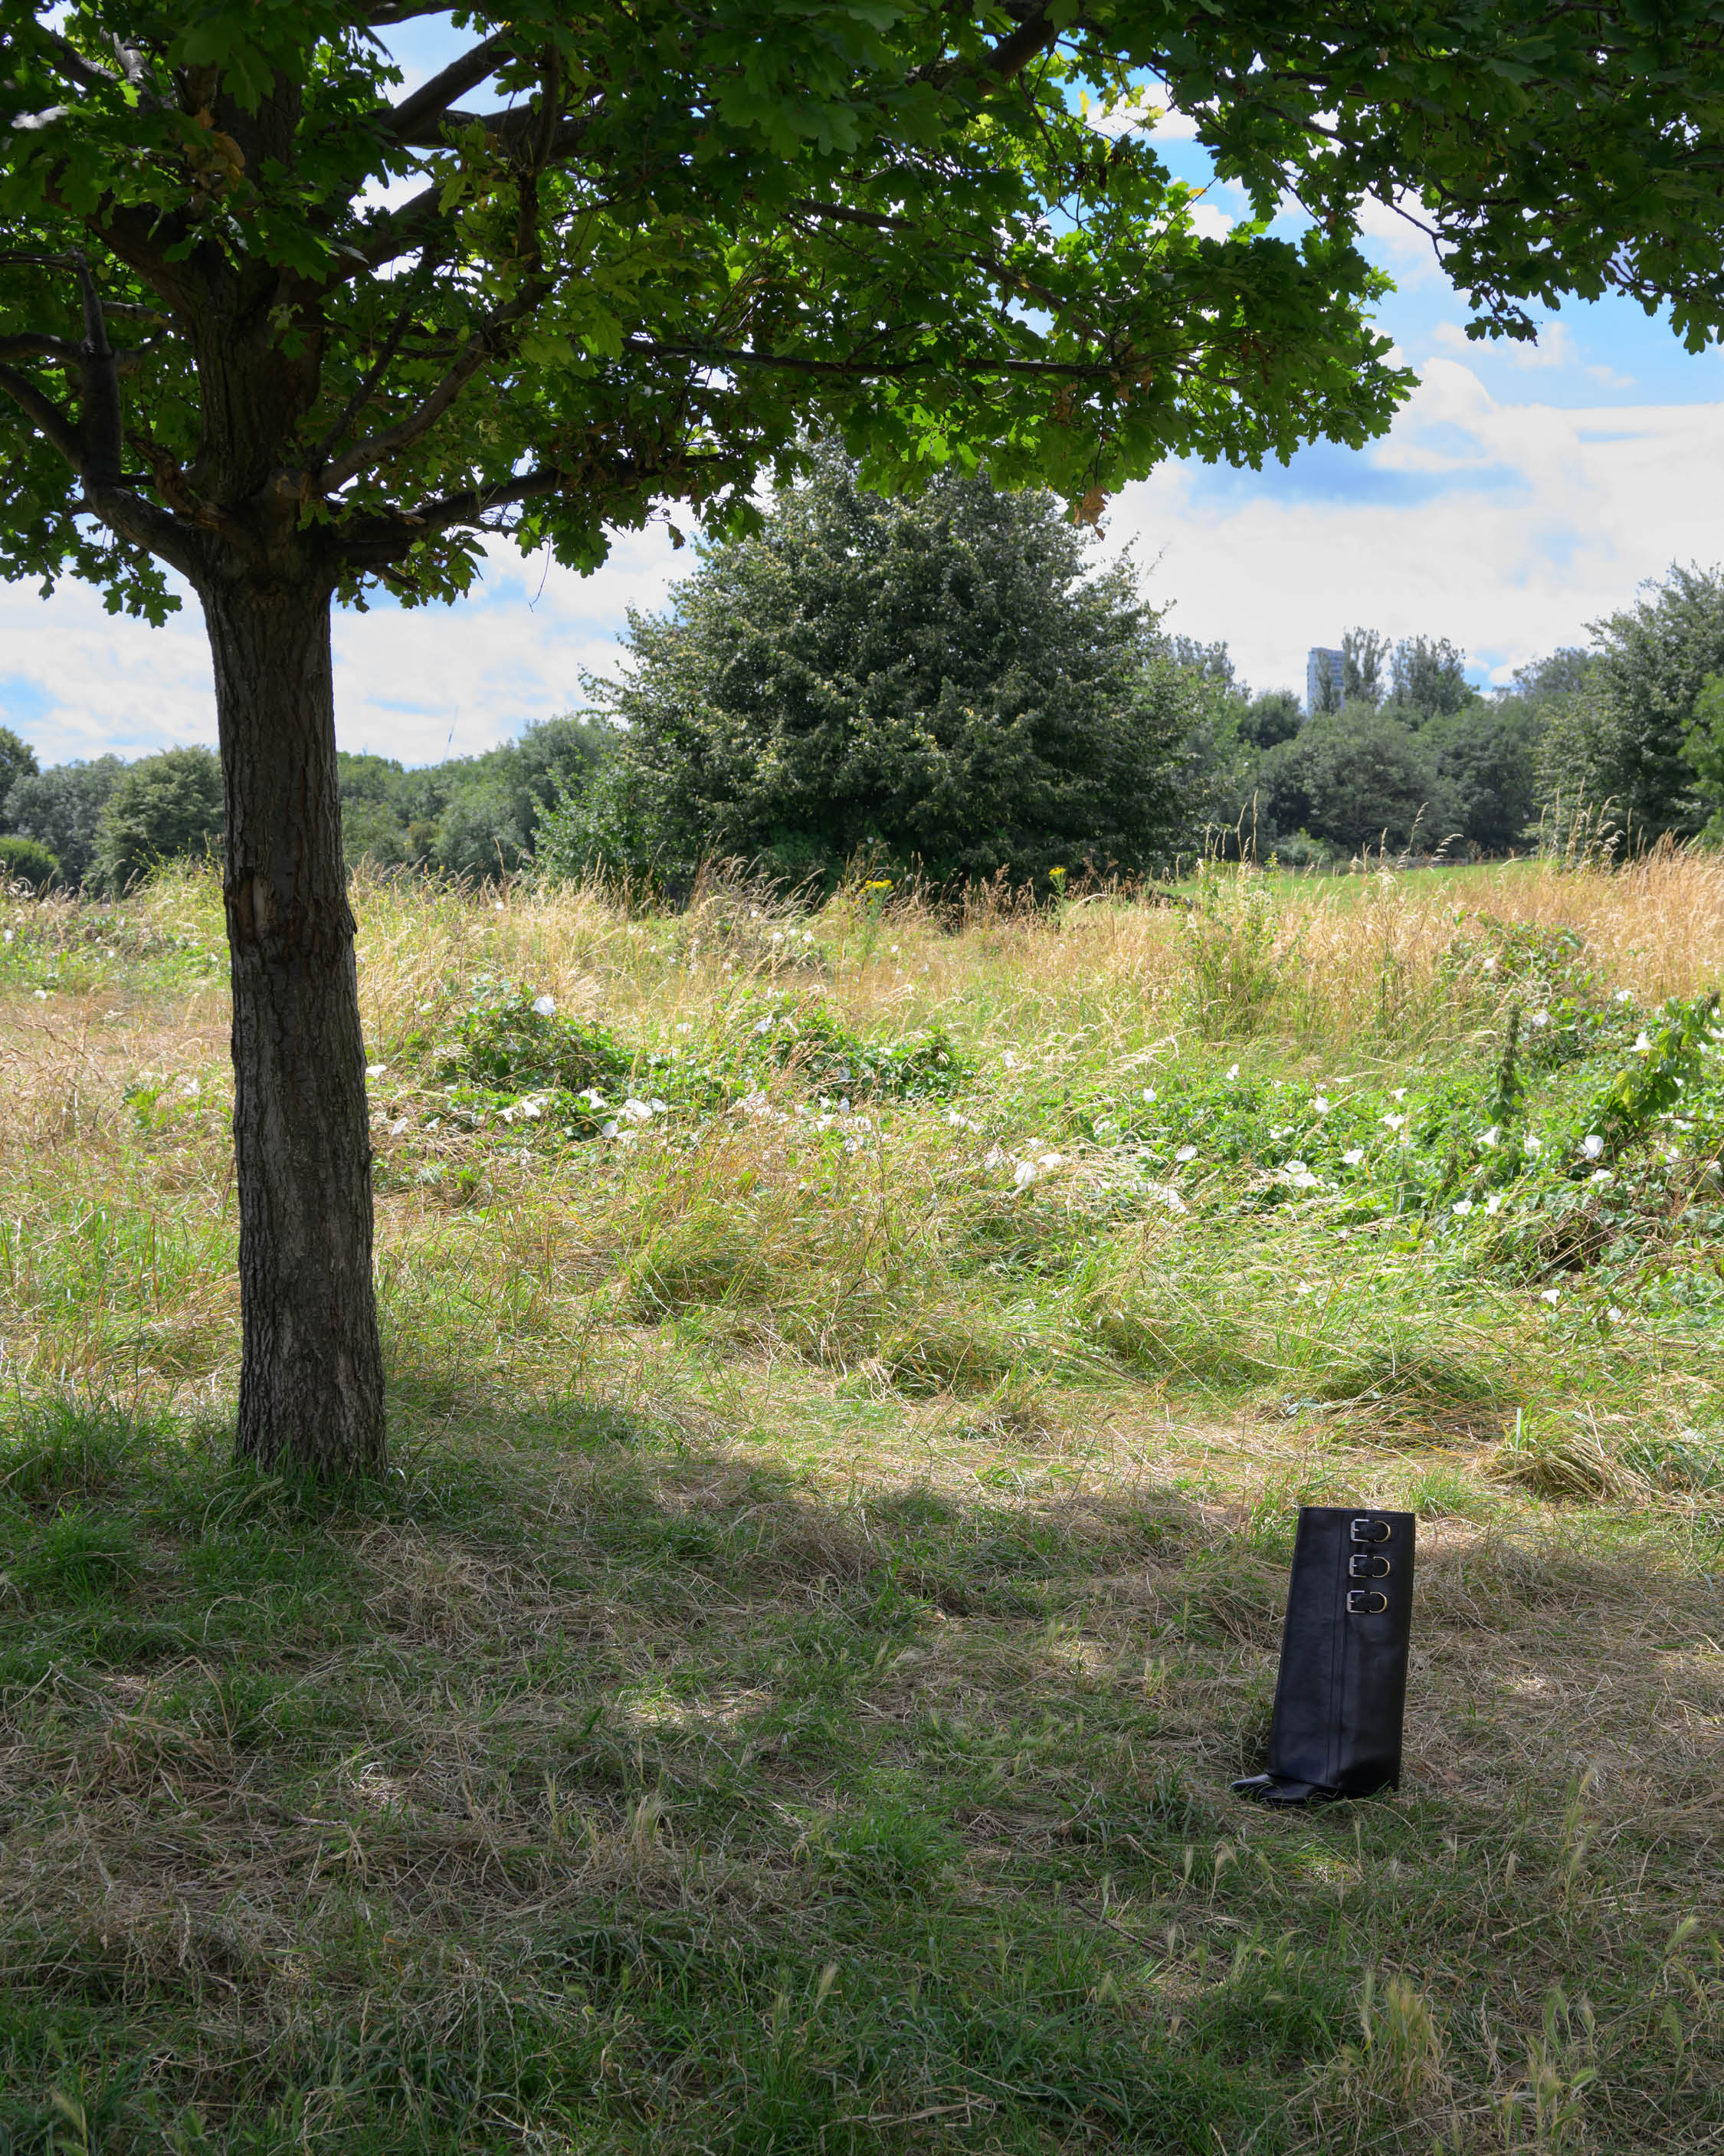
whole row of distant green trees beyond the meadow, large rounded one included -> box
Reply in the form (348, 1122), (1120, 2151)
(0, 455), (1724, 891)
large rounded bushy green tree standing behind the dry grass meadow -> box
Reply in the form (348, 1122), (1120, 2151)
(546, 455), (1205, 884)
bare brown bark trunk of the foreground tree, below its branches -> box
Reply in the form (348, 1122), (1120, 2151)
(198, 578), (385, 1482)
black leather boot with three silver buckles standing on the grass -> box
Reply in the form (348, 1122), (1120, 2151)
(1233, 1505), (1416, 1804)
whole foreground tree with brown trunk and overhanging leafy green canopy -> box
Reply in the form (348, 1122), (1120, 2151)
(0, 0), (1724, 1472)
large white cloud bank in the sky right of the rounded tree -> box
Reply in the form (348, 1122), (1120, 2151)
(1108, 360), (1724, 687)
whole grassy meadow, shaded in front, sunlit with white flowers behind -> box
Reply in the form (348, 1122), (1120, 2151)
(0, 856), (1724, 2156)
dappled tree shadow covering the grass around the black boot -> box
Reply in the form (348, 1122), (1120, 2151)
(0, 1393), (1724, 2156)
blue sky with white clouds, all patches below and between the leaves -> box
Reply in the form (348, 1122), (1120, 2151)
(0, 19), (1724, 763)
